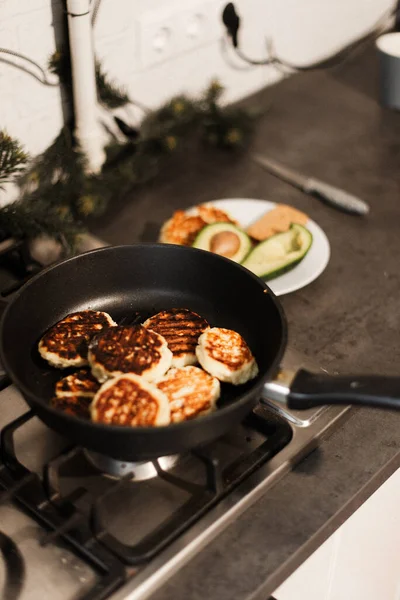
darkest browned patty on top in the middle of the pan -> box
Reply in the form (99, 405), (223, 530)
(88, 325), (172, 383)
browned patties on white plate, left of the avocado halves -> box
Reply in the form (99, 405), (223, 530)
(159, 204), (235, 246)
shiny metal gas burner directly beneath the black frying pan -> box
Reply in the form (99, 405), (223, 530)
(84, 450), (179, 481)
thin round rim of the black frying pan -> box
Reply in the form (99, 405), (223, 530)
(0, 242), (288, 436)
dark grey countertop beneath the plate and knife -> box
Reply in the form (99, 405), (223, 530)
(92, 51), (400, 600)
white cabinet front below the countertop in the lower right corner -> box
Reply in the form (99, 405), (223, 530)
(274, 470), (400, 600)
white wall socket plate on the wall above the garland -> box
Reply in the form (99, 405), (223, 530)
(139, 1), (223, 69)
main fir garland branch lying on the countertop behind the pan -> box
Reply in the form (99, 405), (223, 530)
(21, 82), (253, 226)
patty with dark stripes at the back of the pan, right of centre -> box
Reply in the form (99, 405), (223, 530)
(143, 308), (209, 367)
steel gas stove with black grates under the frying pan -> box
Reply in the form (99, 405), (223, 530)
(0, 239), (348, 600)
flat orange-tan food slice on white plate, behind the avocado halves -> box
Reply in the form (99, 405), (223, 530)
(246, 204), (308, 242)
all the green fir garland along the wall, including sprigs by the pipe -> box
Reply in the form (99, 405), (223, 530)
(0, 53), (255, 251)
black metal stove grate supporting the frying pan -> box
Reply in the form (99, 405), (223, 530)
(0, 409), (292, 600)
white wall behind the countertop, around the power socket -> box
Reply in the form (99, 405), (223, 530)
(0, 0), (393, 162)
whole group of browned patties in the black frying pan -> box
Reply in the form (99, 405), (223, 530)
(39, 308), (258, 427)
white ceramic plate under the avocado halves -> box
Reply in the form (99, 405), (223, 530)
(189, 198), (330, 296)
